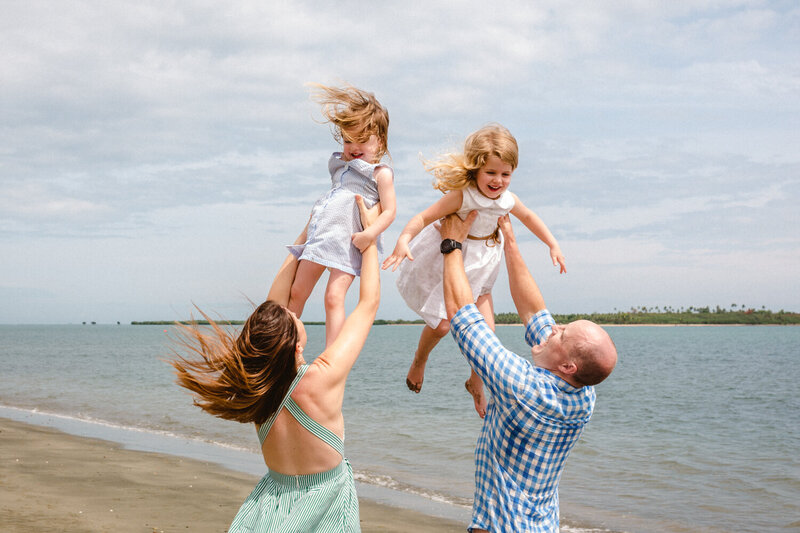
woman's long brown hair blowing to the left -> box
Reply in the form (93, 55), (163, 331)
(170, 300), (298, 424)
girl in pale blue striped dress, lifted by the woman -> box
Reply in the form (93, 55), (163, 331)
(287, 84), (396, 346)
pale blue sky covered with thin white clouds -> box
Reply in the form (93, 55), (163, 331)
(0, 0), (800, 324)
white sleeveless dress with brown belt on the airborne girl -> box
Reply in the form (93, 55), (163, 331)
(397, 186), (514, 328)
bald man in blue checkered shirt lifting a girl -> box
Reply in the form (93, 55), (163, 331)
(441, 213), (617, 532)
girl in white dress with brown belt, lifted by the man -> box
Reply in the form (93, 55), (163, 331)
(383, 124), (566, 418)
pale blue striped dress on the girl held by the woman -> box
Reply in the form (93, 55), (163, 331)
(287, 152), (388, 276)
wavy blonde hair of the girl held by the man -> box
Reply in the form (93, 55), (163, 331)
(422, 124), (519, 192)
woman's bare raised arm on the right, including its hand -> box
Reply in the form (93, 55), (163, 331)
(314, 196), (381, 386)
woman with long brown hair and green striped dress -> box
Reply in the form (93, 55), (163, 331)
(172, 196), (380, 532)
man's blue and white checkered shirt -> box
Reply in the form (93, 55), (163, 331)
(450, 304), (595, 532)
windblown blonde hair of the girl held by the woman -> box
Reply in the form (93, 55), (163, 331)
(309, 83), (389, 160)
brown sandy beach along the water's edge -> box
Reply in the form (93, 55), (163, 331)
(0, 418), (466, 533)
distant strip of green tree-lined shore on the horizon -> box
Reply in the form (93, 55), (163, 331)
(131, 304), (800, 326)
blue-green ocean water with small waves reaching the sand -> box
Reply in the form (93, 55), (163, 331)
(0, 325), (800, 533)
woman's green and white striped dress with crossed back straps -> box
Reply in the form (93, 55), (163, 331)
(228, 365), (361, 533)
